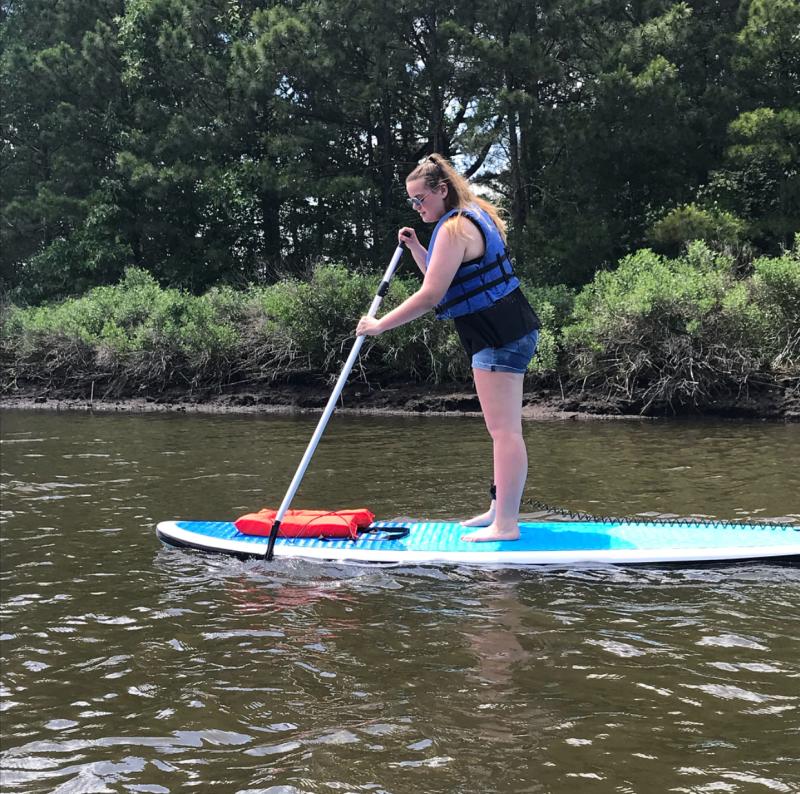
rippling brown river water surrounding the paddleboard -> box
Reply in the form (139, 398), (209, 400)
(0, 411), (800, 794)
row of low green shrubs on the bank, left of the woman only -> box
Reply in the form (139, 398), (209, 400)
(3, 265), (482, 395)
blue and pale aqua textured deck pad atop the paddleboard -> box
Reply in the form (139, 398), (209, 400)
(176, 521), (800, 556)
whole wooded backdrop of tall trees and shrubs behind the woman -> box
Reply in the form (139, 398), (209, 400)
(0, 0), (800, 412)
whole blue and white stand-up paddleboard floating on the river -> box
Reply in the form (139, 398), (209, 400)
(156, 521), (800, 566)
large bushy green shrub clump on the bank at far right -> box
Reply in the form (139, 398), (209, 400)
(564, 241), (800, 410)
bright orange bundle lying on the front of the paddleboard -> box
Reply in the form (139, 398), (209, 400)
(234, 507), (375, 540)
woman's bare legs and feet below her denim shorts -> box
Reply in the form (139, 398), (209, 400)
(463, 369), (528, 541)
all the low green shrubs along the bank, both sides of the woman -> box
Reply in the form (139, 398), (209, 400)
(0, 251), (800, 411)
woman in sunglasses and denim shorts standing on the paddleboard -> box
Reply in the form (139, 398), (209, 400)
(356, 154), (539, 541)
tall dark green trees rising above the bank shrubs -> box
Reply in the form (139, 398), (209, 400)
(0, 0), (800, 304)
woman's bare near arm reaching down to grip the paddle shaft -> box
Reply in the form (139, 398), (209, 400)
(356, 224), (466, 336)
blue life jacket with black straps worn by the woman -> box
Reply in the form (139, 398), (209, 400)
(425, 206), (519, 320)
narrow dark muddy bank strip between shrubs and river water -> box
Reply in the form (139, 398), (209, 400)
(0, 381), (800, 422)
